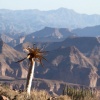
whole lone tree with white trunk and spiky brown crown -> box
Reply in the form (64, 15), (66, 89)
(17, 46), (47, 95)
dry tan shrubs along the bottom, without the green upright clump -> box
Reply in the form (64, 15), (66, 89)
(0, 86), (100, 100)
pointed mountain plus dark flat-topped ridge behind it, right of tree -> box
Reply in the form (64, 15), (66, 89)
(33, 37), (100, 87)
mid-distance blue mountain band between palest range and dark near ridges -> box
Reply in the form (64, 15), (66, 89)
(0, 25), (100, 47)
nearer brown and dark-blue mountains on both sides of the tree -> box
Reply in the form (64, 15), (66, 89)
(0, 37), (100, 87)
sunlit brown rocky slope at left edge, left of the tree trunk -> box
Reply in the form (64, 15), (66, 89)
(0, 40), (27, 78)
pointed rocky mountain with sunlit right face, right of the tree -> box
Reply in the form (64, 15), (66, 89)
(35, 46), (98, 87)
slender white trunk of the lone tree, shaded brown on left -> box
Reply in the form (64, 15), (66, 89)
(26, 58), (35, 95)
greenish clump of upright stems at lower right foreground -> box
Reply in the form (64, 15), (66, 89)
(63, 85), (99, 100)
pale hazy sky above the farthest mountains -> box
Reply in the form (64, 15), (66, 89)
(0, 0), (100, 14)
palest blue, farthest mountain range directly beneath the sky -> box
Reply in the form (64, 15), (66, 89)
(0, 8), (100, 36)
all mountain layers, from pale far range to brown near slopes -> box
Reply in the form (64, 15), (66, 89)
(0, 8), (100, 94)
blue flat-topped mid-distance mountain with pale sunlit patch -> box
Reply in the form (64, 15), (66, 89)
(23, 27), (75, 42)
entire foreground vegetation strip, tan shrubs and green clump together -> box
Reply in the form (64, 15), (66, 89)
(0, 85), (99, 100)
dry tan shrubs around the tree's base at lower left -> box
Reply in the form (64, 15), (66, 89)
(0, 85), (50, 100)
